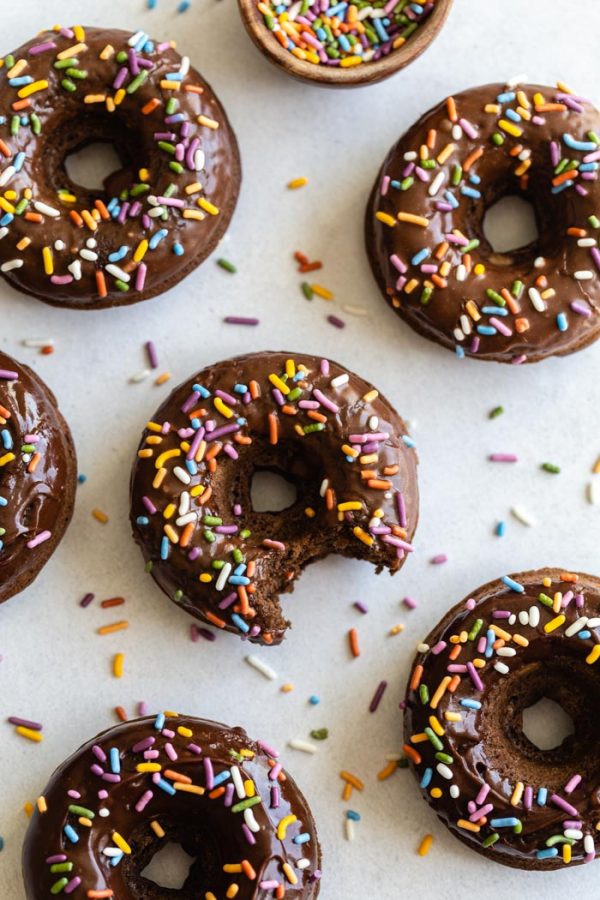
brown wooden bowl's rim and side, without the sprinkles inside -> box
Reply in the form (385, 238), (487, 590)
(238, 0), (452, 87)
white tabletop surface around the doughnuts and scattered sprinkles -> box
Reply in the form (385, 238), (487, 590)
(0, 0), (600, 900)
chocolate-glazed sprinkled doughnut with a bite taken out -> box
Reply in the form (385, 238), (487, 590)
(131, 352), (418, 643)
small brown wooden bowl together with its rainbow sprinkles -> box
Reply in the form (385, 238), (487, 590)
(238, 0), (452, 87)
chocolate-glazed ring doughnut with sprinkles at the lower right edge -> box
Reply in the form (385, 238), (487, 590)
(404, 569), (600, 870)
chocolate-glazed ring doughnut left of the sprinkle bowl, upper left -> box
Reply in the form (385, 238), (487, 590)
(0, 28), (241, 309)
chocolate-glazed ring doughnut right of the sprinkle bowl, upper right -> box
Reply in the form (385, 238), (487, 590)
(366, 84), (600, 362)
